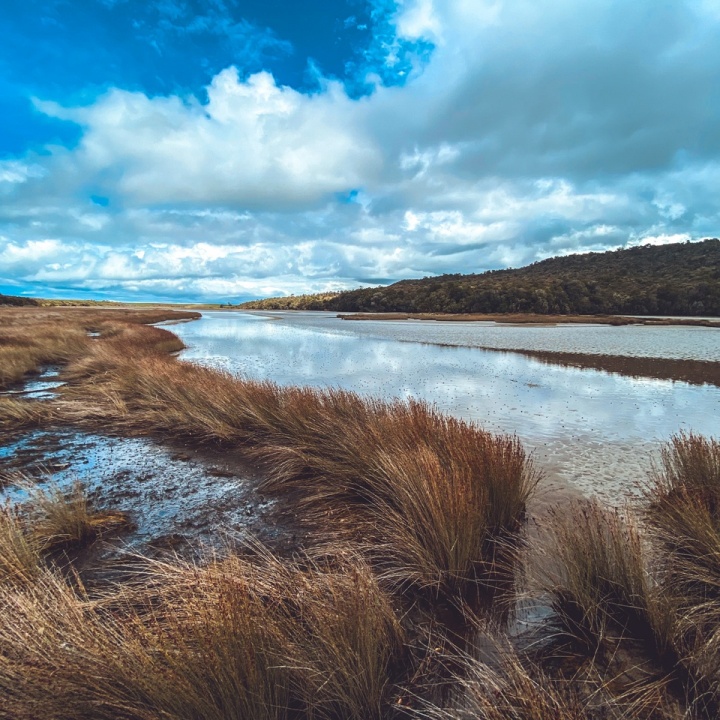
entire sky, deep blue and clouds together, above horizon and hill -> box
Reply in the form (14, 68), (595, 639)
(0, 0), (720, 303)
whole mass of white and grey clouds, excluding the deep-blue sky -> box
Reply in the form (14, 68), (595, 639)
(0, 0), (720, 299)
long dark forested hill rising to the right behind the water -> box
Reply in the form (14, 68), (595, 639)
(240, 239), (720, 315)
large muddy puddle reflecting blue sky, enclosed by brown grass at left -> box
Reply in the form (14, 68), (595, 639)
(0, 429), (279, 550)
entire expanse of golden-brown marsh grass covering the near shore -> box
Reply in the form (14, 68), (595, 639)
(5, 309), (720, 720)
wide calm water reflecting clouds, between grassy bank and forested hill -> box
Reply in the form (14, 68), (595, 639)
(172, 312), (720, 502)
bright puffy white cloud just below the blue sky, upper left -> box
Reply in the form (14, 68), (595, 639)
(37, 68), (382, 209)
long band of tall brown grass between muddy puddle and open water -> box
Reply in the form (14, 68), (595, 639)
(59, 346), (537, 594)
